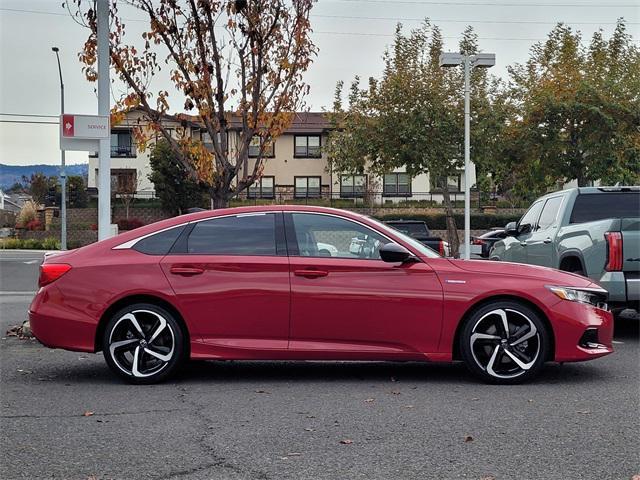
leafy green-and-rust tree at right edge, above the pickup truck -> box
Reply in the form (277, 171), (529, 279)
(510, 20), (640, 192)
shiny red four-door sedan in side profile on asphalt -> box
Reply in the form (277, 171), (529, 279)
(29, 206), (613, 383)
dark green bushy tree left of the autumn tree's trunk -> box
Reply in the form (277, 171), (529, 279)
(149, 140), (207, 215)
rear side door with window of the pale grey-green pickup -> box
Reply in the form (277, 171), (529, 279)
(527, 195), (564, 267)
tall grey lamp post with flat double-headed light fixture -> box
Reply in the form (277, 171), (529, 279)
(440, 52), (496, 260)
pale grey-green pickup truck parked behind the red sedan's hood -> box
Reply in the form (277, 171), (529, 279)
(490, 187), (640, 310)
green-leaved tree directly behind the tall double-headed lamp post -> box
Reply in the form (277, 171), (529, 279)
(327, 21), (504, 254)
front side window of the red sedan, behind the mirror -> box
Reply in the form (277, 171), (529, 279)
(291, 213), (390, 260)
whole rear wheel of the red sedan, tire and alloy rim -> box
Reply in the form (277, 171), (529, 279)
(102, 303), (186, 384)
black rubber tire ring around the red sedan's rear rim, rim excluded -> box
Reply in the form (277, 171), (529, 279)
(102, 303), (185, 385)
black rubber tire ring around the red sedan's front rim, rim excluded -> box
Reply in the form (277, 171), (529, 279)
(460, 300), (551, 385)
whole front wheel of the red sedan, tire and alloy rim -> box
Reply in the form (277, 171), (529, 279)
(460, 301), (551, 384)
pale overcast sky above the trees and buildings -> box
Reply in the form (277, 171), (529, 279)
(0, 0), (640, 165)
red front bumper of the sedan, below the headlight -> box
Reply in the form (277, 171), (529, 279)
(551, 300), (613, 362)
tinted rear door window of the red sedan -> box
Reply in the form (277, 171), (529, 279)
(187, 213), (277, 256)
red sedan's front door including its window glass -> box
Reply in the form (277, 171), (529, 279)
(285, 213), (442, 358)
